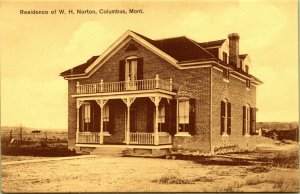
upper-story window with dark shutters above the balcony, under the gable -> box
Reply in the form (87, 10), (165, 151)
(119, 56), (144, 81)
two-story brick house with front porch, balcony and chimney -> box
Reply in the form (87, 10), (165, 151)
(60, 31), (262, 153)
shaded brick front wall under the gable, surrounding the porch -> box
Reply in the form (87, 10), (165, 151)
(68, 40), (210, 150)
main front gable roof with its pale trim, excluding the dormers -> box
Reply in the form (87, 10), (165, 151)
(60, 30), (216, 78)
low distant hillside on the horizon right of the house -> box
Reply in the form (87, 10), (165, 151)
(256, 122), (299, 130)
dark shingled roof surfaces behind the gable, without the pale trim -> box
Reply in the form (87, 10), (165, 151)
(60, 31), (221, 76)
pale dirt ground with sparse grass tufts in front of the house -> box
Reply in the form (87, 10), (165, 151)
(2, 142), (299, 192)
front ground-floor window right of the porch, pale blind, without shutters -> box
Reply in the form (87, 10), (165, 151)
(178, 100), (190, 132)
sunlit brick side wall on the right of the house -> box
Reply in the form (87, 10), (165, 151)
(212, 68), (257, 149)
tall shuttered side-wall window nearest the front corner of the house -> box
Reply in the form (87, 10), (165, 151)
(220, 99), (231, 135)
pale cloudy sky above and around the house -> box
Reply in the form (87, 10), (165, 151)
(0, 0), (299, 129)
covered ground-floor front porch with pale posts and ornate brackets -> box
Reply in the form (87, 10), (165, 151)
(73, 90), (176, 146)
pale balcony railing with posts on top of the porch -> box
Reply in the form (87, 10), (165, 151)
(76, 75), (173, 94)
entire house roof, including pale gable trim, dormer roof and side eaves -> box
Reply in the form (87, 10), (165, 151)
(60, 31), (260, 84)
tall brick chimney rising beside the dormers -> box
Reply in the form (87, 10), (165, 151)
(228, 33), (240, 68)
